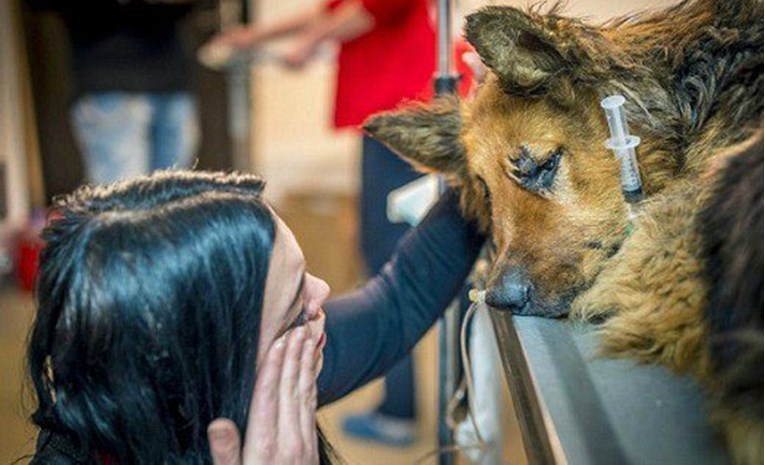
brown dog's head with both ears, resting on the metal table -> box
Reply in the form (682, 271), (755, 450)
(365, 1), (762, 316)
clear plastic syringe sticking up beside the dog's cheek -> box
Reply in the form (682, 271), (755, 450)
(600, 95), (643, 203)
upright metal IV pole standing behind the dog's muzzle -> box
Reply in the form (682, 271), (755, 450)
(433, 0), (460, 465)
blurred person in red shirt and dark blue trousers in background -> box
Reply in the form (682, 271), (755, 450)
(211, 0), (436, 445)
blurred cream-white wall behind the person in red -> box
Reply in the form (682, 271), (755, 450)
(253, 0), (676, 203)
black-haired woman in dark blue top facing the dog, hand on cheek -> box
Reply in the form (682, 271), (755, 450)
(28, 171), (482, 464)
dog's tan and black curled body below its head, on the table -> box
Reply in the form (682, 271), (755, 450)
(572, 133), (763, 464)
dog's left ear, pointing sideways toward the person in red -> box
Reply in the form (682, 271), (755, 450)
(364, 96), (467, 181)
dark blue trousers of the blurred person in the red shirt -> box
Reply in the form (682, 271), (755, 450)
(361, 136), (421, 419)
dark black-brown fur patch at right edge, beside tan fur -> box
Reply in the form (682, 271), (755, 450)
(697, 134), (764, 463)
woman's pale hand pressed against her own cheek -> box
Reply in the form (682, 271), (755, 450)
(207, 327), (319, 465)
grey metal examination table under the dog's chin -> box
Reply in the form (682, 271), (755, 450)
(490, 310), (726, 465)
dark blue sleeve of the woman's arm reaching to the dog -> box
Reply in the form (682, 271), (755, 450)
(318, 190), (484, 405)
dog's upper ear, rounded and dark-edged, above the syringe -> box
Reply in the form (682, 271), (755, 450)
(465, 6), (584, 96)
